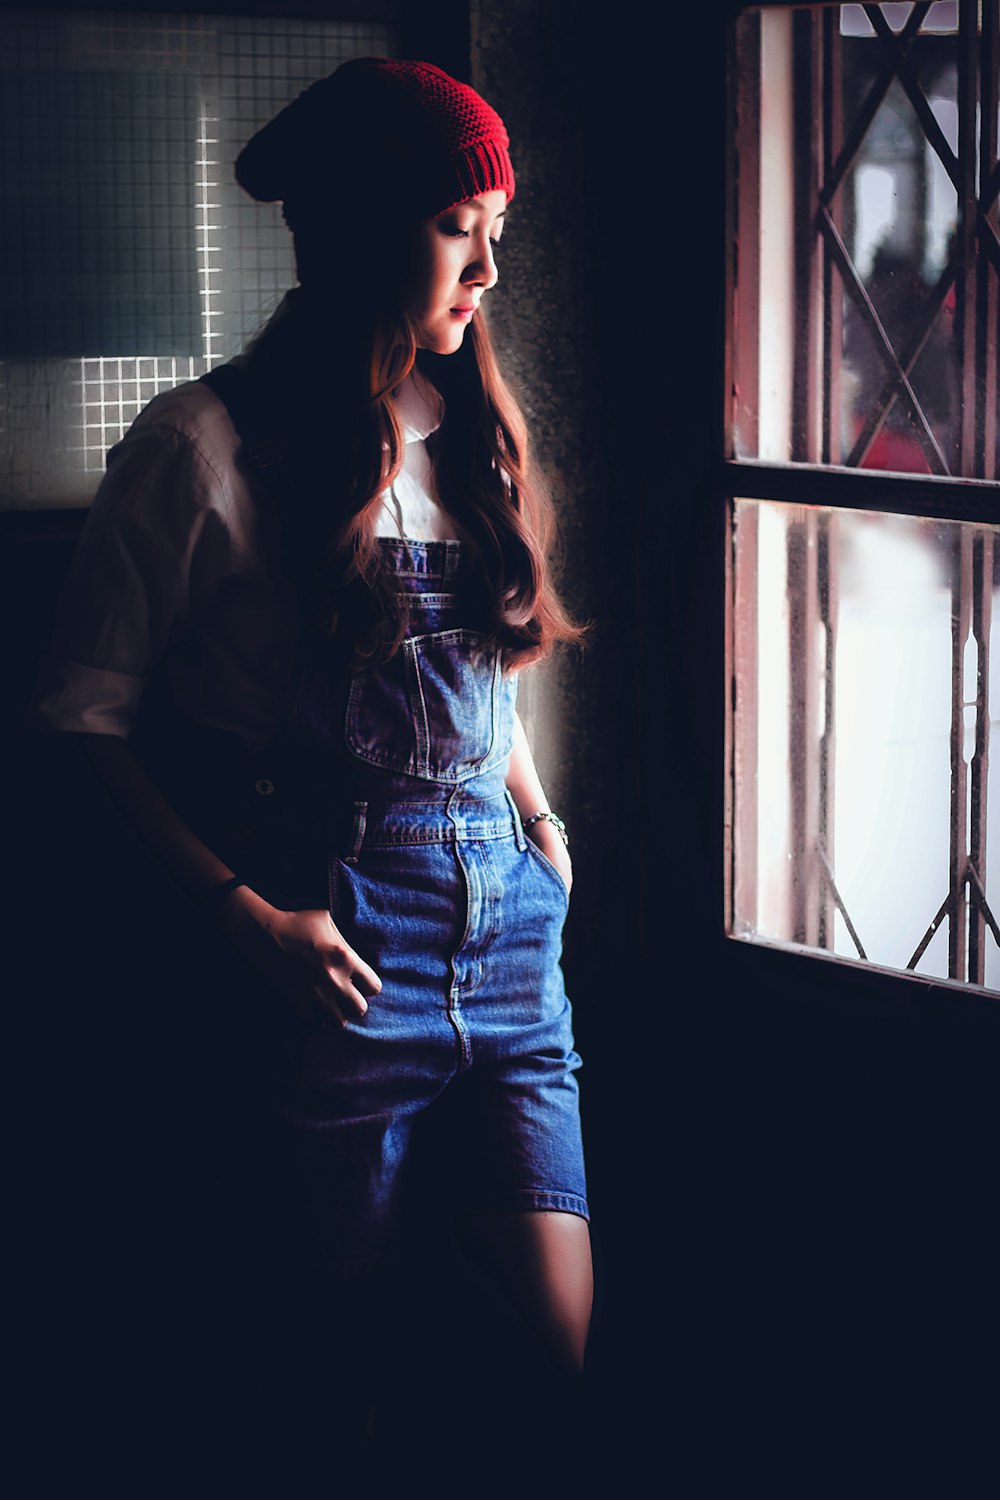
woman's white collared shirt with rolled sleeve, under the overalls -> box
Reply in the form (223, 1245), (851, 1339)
(31, 360), (460, 743)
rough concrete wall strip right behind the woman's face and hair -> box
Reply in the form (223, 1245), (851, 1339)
(469, 0), (606, 828)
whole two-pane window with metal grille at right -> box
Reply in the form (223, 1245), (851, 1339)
(726, 0), (1000, 992)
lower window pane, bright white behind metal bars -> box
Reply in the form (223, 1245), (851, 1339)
(733, 501), (1000, 990)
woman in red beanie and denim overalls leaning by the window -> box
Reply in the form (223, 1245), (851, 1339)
(36, 59), (592, 1452)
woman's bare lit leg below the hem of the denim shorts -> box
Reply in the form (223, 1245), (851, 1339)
(459, 1211), (594, 1376)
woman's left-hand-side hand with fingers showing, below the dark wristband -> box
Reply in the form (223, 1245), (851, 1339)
(219, 887), (382, 1026)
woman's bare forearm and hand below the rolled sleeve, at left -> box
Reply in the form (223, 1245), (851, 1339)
(75, 735), (382, 1023)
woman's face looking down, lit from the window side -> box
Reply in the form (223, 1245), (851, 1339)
(406, 191), (507, 354)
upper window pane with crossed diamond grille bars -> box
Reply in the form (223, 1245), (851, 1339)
(730, 0), (1000, 479)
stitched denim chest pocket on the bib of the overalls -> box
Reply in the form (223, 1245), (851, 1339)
(345, 630), (517, 783)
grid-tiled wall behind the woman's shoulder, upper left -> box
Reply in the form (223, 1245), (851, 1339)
(0, 9), (396, 507)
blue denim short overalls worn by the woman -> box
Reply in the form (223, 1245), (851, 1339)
(186, 368), (589, 1268)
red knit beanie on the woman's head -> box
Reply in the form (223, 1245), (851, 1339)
(235, 57), (514, 230)
